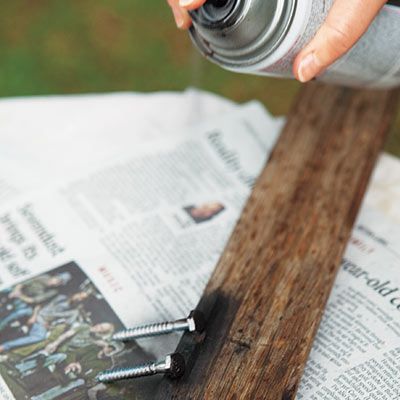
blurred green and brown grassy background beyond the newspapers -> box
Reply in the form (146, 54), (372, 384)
(0, 0), (400, 156)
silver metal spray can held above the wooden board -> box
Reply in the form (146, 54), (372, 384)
(190, 0), (400, 88)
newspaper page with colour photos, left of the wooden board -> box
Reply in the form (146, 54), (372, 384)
(0, 105), (281, 400)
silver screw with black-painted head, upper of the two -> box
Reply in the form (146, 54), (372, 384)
(113, 310), (205, 342)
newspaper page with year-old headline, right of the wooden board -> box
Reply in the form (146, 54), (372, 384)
(297, 207), (400, 400)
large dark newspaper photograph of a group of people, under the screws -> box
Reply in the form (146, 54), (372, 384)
(0, 263), (152, 400)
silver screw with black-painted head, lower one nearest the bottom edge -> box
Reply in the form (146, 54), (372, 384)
(96, 353), (185, 383)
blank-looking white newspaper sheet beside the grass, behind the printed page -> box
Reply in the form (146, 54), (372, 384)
(0, 89), (240, 204)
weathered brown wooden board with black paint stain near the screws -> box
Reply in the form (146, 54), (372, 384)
(157, 83), (397, 400)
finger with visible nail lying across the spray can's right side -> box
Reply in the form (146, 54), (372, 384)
(293, 0), (386, 82)
